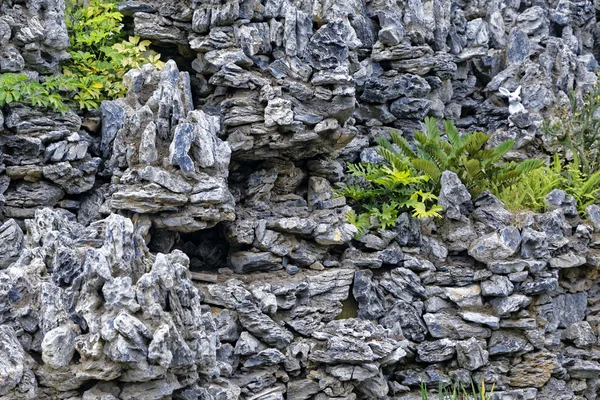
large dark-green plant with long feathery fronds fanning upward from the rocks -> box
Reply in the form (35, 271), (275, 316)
(378, 117), (543, 197)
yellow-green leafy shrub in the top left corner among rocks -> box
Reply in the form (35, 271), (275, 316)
(0, 0), (164, 113)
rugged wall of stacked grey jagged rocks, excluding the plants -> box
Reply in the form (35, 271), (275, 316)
(0, 0), (600, 400)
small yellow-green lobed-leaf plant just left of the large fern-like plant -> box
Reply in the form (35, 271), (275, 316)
(338, 160), (442, 235)
